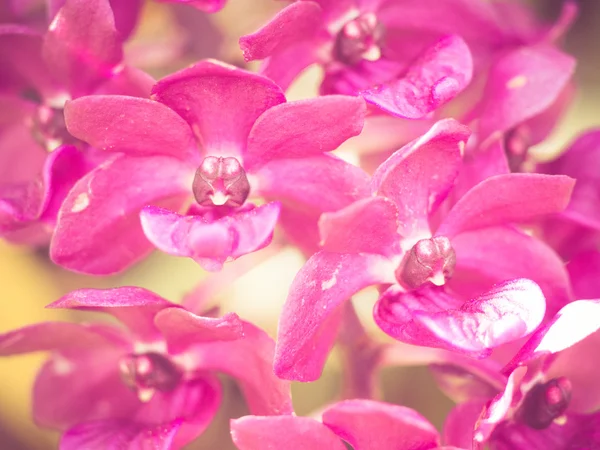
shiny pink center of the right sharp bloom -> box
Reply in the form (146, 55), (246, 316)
(396, 236), (456, 289)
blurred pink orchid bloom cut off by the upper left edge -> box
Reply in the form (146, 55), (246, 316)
(0, 0), (152, 245)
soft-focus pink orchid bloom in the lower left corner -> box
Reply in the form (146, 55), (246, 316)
(0, 287), (291, 450)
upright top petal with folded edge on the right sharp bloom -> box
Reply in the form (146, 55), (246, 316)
(372, 119), (469, 237)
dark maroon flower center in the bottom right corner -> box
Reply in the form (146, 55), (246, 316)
(515, 377), (571, 430)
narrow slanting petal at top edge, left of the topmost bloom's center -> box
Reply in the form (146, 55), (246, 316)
(240, 1), (323, 61)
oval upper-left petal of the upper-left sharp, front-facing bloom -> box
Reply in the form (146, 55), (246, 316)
(65, 95), (199, 163)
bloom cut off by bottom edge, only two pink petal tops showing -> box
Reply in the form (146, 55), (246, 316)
(231, 400), (458, 450)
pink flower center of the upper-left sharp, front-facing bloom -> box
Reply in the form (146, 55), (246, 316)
(192, 156), (250, 207)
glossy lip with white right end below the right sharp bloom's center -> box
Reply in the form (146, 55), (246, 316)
(374, 279), (546, 358)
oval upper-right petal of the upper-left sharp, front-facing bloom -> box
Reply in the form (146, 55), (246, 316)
(244, 95), (367, 170)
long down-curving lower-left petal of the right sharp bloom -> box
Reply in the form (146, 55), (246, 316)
(275, 252), (395, 381)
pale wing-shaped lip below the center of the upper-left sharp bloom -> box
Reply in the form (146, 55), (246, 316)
(140, 202), (280, 270)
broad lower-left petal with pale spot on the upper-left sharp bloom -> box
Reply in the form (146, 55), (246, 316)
(50, 156), (191, 275)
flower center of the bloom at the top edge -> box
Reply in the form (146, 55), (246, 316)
(333, 13), (385, 65)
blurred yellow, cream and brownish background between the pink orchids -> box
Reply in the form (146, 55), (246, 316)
(0, 0), (600, 450)
